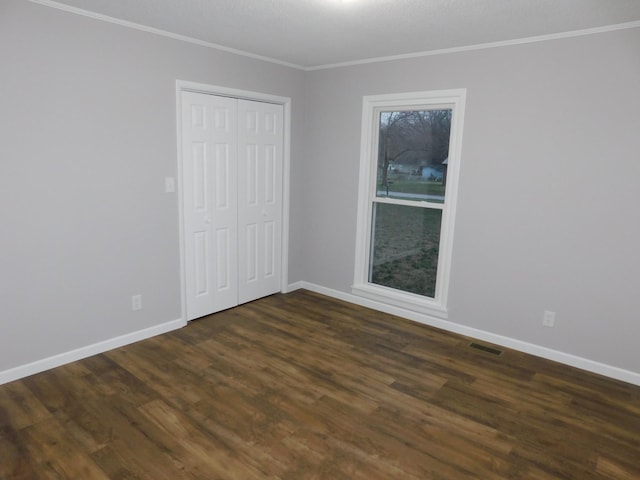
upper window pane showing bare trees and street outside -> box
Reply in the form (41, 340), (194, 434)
(376, 109), (452, 203)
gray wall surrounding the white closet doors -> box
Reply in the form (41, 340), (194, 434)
(0, 0), (304, 372)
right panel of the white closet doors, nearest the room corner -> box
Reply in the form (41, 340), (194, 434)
(238, 100), (284, 303)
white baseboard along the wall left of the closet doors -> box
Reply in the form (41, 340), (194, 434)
(0, 319), (187, 385)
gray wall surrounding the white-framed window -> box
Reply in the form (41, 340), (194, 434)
(300, 28), (640, 372)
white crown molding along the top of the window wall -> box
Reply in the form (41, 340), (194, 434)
(302, 21), (640, 72)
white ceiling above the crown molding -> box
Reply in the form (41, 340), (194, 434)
(40, 0), (640, 68)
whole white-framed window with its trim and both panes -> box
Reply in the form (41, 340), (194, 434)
(353, 90), (466, 318)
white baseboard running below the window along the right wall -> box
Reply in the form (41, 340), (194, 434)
(288, 282), (640, 386)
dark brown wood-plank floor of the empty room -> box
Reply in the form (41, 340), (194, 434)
(0, 291), (640, 480)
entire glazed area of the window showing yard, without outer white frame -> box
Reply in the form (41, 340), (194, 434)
(369, 109), (452, 297)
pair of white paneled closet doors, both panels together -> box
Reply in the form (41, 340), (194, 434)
(181, 92), (284, 320)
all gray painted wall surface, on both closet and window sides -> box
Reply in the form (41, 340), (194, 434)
(0, 0), (640, 382)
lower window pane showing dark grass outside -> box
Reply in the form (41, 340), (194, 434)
(369, 203), (442, 298)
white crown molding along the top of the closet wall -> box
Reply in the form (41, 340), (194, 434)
(29, 0), (305, 70)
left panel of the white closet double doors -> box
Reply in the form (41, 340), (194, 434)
(182, 92), (238, 320)
